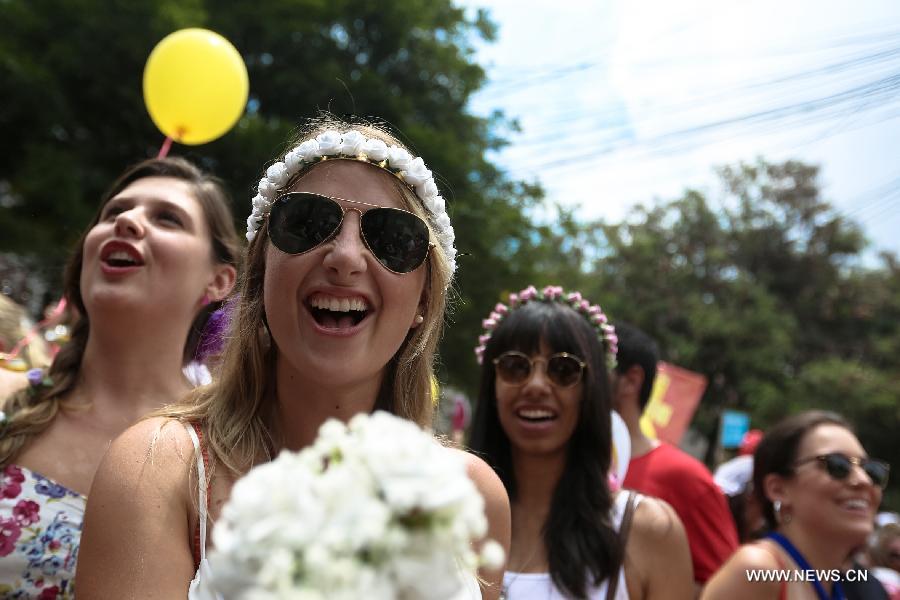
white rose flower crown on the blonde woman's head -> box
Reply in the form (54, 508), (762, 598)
(247, 130), (456, 274)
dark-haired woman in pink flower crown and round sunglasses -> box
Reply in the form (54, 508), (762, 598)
(470, 286), (693, 600)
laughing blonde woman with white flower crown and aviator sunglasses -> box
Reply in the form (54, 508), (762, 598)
(78, 118), (509, 600)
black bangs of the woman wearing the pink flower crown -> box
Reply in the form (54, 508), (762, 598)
(485, 301), (594, 362)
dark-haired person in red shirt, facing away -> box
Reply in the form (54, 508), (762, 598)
(613, 322), (738, 591)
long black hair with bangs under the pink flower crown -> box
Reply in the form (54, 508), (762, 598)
(469, 300), (624, 598)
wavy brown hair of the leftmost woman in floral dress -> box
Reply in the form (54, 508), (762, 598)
(0, 157), (241, 466)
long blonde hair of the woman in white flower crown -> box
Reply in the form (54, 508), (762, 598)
(155, 115), (453, 475)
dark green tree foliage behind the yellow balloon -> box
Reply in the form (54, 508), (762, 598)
(0, 0), (560, 370)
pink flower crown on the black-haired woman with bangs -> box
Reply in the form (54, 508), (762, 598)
(475, 285), (619, 370)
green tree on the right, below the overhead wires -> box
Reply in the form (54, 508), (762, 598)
(585, 161), (900, 502)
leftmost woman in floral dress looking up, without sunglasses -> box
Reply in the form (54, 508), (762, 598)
(0, 158), (240, 598)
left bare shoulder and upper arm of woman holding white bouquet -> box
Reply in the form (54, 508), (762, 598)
(76, 418), (194, 598)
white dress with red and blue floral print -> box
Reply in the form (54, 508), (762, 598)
(0, 465), (86, 600)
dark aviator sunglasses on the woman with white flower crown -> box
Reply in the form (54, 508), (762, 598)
(269, 192), (431, 274)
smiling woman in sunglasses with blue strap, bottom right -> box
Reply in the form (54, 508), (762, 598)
(703, 411), (889, 600)
